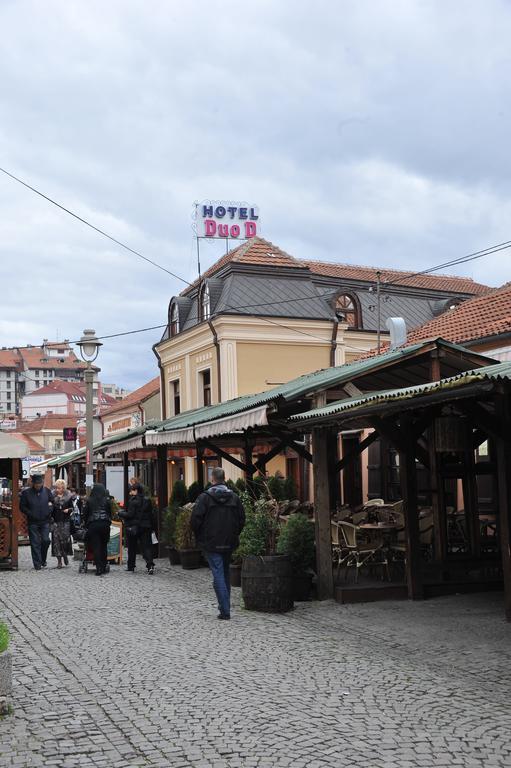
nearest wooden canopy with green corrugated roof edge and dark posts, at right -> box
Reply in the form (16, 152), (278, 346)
(290, 363), (511, 620)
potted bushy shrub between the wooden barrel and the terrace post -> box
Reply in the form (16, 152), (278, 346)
(277, 514), (315, 601)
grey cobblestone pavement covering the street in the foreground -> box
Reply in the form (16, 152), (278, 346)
(0, 549), (511, 768)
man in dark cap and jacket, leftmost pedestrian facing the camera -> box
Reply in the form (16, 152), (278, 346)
(20, 475), (53, 571)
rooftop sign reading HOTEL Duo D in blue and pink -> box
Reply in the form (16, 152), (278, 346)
(195, 201), (259, 240)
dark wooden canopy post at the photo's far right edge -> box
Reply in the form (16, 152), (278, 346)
(495, 394), (511, 621)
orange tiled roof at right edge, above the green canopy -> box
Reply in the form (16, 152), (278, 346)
(408, 283), (511, 343)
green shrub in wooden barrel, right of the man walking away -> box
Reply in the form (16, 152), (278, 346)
(239, 498), (293, 613)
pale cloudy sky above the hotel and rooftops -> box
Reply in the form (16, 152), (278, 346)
(0, 0), (511, 388)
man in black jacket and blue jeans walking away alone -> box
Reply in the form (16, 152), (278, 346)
(192, 467), (245, 619)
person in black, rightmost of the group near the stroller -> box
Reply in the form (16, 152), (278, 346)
(119, 483), (154, 575)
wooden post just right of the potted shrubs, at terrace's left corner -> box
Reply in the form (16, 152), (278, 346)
(312, 427), (334, 600)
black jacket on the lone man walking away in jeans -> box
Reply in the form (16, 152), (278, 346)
(192, 485), (245, 552)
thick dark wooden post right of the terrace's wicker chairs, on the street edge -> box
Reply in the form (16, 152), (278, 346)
(399, 419), (424, 600)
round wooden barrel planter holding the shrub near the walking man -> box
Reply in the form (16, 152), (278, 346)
(241, 555), (293, 613)
